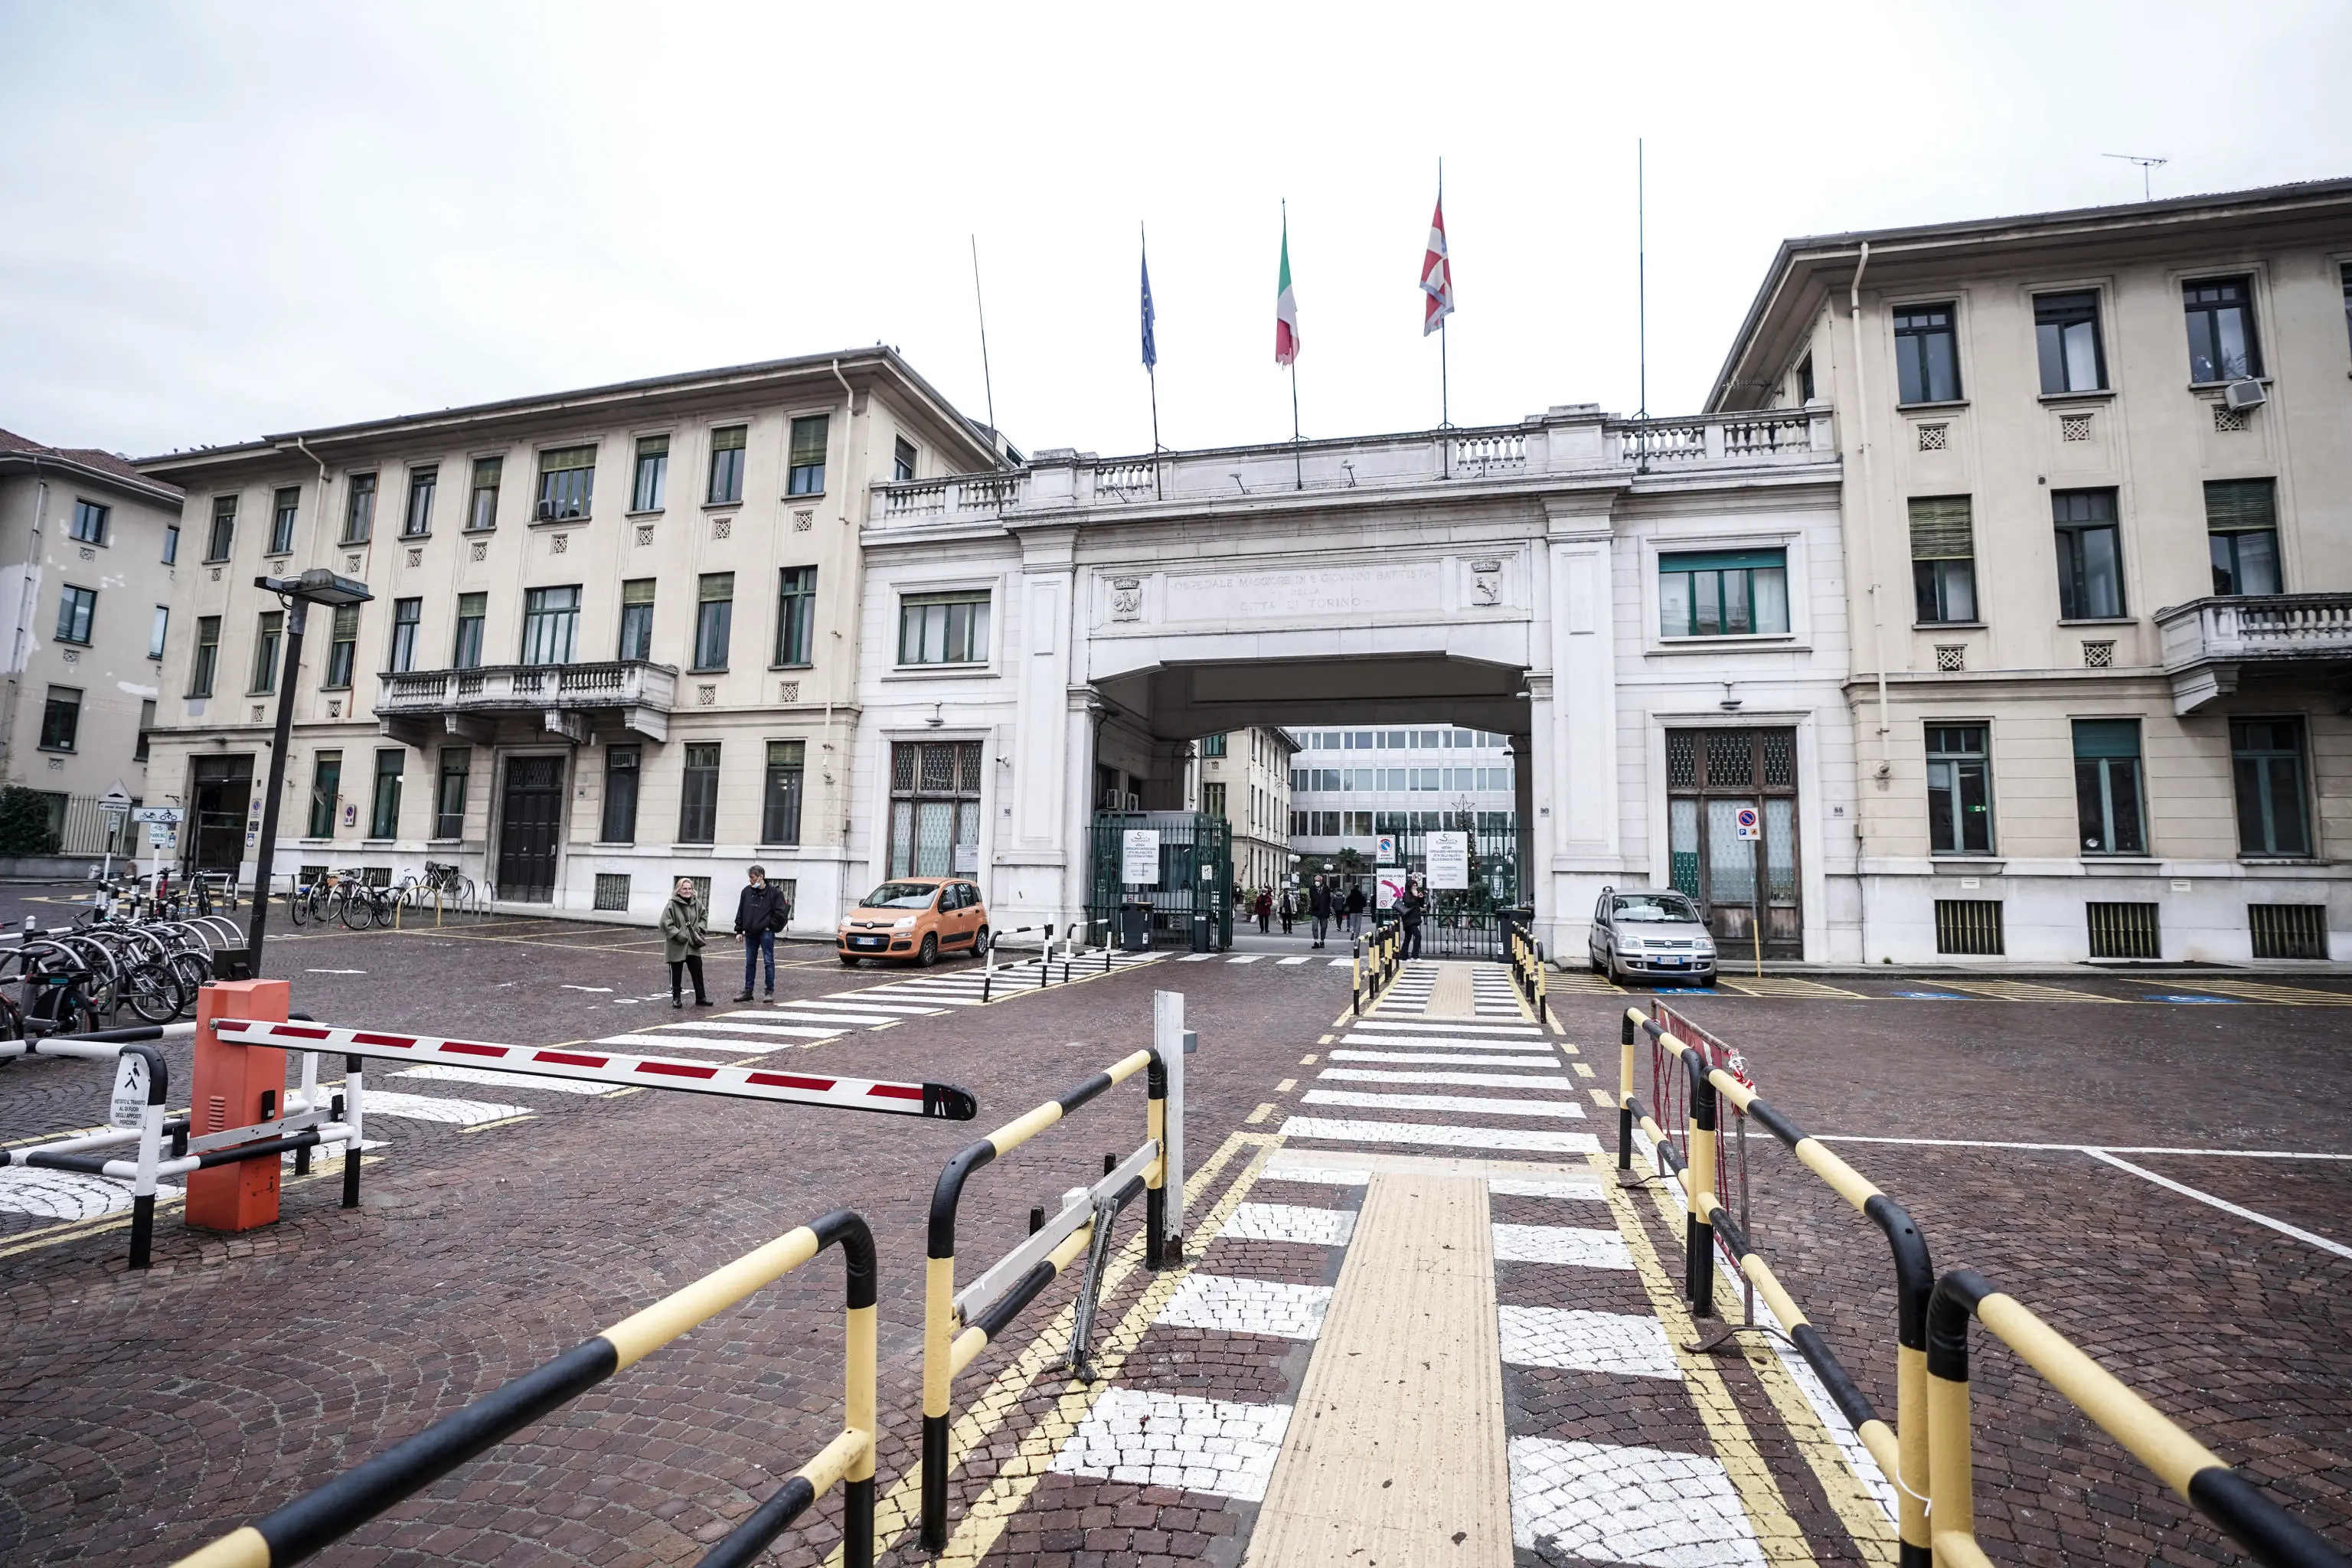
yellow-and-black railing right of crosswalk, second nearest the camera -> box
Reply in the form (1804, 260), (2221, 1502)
(1619, 1008), (1936, 1568)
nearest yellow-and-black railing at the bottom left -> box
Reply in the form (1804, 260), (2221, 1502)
(176, 1208), (877, 1568)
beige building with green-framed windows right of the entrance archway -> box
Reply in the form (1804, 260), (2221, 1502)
(1710, 181), (2352, 962)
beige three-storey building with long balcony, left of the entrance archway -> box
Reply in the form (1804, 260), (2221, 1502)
(141, 348), (998, 931)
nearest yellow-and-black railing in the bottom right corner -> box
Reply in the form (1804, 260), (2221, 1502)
(1926, 1269), (2352, 1568)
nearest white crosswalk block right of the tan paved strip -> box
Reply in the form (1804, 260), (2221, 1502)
(1510, 1436), (1764, 1568)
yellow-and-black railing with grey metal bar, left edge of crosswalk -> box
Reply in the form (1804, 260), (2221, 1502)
(922, 1048), (1183, 1552)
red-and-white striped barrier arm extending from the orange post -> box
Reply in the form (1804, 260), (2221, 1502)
(214, 1018), (978, 1122)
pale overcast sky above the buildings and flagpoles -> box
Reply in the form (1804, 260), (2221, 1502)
(0, 0), (2352, 465)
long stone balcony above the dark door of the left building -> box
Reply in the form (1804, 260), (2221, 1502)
(377, 658), (678, 745)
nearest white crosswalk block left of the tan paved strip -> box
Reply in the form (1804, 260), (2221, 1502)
(1054, 1387), (1292, 1502)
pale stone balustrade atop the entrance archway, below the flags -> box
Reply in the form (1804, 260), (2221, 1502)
(865, 404), (1837, 527)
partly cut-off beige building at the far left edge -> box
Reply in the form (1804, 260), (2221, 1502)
(0, 430), (191, 856)
